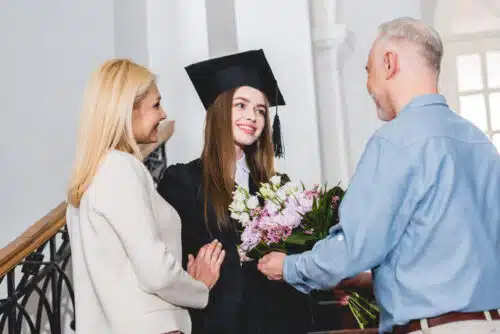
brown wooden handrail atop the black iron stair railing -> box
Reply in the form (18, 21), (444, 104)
(0, 202), (66, 277)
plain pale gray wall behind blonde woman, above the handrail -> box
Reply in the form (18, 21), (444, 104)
(0, 0), (114, 246)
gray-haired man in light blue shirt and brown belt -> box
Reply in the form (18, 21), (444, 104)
(259, 18), (500, 334)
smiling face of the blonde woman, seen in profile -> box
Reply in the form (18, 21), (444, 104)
(132, 84), (165, 144)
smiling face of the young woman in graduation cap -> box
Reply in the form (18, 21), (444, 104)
(231, 86), (268, 149)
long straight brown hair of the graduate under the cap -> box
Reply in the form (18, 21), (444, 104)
(202, 89), (274, 229)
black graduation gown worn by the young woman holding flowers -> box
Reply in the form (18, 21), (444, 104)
(158, 159), (311, 334)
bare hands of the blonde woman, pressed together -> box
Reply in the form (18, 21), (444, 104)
(187, 240), (226, 289)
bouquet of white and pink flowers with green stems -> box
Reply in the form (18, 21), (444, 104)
(229, 175), (378, 328)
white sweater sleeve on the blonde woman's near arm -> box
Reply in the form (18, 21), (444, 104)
(95, 152), (208, 308)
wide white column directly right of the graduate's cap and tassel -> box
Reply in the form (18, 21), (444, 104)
(234, 0), (322, 185)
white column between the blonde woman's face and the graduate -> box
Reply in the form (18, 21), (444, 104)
(147, 0), (209, 164)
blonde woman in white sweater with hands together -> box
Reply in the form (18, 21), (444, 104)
(66, 59), (225, 334)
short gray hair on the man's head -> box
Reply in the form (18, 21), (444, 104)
(378, 17), (443, 76)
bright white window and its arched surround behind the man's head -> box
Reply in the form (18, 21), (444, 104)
(433, 0), (500, 152)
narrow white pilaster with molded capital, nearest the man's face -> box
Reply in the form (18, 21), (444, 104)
(311, 0), (350, 187)
